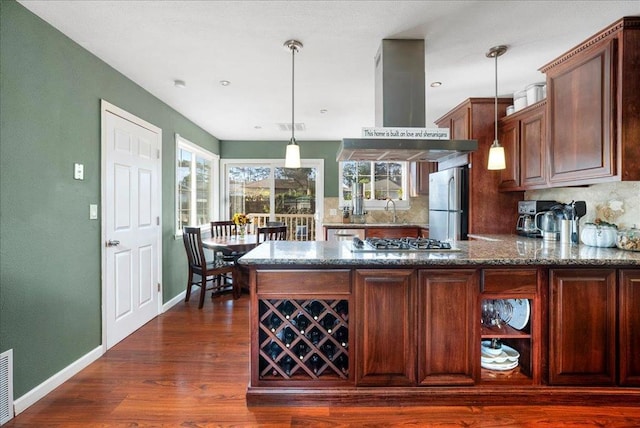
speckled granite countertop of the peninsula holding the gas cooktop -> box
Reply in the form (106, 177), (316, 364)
(239, 235), (640, 267)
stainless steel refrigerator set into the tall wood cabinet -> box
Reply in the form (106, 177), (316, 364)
(429, 166), (469, 241)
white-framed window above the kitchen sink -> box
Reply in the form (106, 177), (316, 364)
(339, 161), (409, 209)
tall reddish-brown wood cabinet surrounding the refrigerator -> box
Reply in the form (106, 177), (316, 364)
(436, 98), (524, 234)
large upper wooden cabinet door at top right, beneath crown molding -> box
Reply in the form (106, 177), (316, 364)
(547, 39), (616, 184)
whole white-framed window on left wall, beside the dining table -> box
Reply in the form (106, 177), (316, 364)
(176, 134), (219, 235)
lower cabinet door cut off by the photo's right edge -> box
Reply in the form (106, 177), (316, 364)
(618, 269), (640, 386)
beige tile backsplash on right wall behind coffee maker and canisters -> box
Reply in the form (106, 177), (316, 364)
(525, 181), (640, 228)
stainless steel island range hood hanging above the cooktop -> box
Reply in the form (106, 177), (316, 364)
(336, 39), (478, 162)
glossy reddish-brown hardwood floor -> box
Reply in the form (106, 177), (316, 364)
(3, 295), (640, 428)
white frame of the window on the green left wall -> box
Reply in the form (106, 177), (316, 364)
(173, 133), (220, 237)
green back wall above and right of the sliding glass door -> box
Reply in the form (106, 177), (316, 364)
(220, 140), (340, 197)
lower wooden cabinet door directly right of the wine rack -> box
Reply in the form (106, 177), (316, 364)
(355, 269), (416, 386)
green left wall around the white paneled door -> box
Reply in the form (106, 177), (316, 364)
(0, 0), (220, 398)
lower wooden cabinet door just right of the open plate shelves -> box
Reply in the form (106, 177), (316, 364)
(549, 269), (616, 385)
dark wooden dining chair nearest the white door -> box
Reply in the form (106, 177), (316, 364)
(182, 227), (240, 309)
